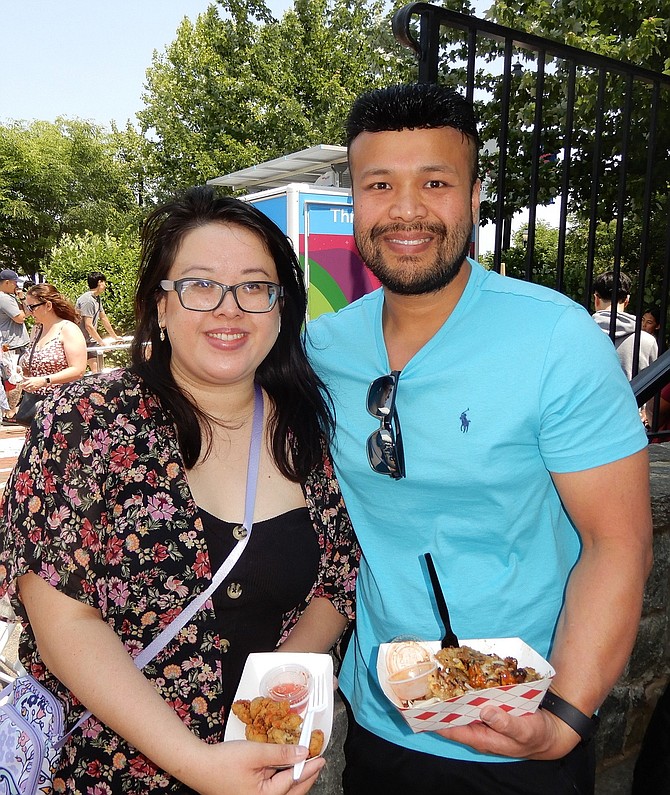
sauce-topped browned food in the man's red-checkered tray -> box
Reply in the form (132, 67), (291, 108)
(428, 646), (541, 701)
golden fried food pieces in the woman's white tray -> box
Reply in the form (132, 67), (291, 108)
(232, 696), (324, 759)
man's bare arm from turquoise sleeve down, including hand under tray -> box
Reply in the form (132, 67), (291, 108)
(440, 449), (652, 759)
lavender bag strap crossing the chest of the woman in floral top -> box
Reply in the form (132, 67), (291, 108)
(55, 384), (263, 748)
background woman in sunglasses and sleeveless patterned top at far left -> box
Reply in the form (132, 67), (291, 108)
(19, 284), (86, 397)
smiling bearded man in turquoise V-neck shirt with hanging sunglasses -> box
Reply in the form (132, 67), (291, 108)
(308, 84), (651, 795)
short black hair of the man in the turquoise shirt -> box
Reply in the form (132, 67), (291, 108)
(345, 83), (481, 184)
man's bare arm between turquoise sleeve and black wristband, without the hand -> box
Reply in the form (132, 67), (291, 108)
(552, 449), (653, 715)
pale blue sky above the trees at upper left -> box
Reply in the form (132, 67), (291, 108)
(0, 0), (292, 126)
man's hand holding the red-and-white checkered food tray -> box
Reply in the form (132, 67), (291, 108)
(437, 707), (580, 759)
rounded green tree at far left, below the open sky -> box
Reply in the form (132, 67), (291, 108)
(0, 119), (138, 273)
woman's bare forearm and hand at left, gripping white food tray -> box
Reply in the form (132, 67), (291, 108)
(18, 573), (324, 795)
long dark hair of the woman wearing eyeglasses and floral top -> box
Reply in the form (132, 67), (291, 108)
(132, 187), (333, 482)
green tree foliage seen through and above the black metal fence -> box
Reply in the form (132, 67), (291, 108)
(434, 0), (670, 308)
